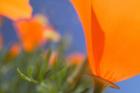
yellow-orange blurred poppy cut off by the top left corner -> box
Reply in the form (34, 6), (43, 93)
(0, 0), (32, 20)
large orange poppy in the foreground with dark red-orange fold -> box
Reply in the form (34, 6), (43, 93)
(71, 0), (140, 82)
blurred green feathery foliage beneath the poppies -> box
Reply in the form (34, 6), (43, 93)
(0, 39), (93, 93)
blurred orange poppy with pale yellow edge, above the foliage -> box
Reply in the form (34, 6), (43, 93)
(15, 16), (60, 52)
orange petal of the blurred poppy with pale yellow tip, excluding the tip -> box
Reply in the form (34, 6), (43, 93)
(15, 18), (45, 52)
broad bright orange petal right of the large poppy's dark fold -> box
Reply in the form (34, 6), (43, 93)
(92, 0), (140, 82)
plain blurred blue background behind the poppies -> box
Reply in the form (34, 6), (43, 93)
(0, 0), (140, 93)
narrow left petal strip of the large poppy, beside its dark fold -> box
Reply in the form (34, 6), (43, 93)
(71, 0), (96, 73)
